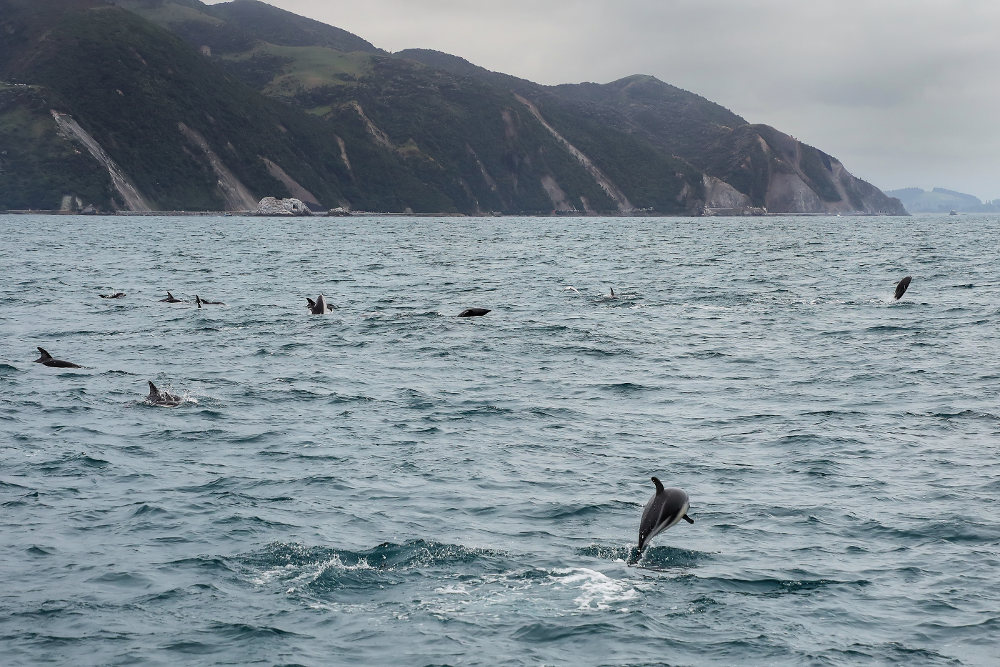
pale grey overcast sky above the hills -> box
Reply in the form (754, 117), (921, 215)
(210, 0), (1000, 200)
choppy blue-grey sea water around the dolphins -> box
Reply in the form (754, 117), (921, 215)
(0, 215), (1000, 665)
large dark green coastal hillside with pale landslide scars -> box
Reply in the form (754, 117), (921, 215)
(0, 0), (905, 214)
